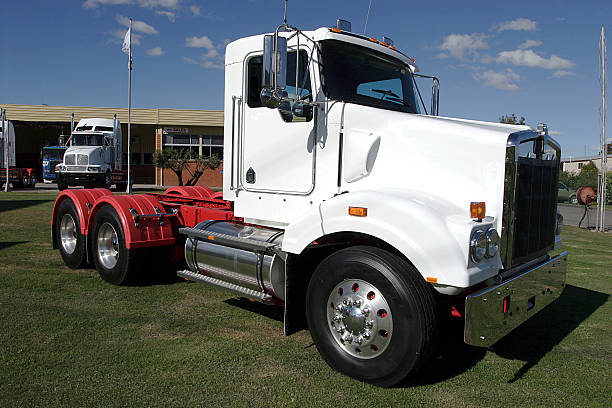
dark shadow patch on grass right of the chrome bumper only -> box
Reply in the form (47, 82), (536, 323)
(492, 285), (610, 383)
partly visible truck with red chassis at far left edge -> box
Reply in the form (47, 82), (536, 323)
(0, 121), (38, 188)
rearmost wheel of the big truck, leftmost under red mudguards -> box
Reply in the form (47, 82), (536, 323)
(53, 198), (87, 269)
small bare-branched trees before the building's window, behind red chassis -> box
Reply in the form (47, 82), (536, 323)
(153, 149), (221, 186)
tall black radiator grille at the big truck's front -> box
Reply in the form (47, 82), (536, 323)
(512, 157), (558, 264)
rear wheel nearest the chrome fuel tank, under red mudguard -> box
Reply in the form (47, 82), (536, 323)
(91, 205), (141, 285)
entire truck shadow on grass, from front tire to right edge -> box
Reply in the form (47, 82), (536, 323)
(398, 285), (610, 387)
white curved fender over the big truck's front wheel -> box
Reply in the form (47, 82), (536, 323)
(283, 191), (472, 287)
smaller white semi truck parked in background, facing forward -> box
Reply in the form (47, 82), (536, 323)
(55, 118), (127, 191)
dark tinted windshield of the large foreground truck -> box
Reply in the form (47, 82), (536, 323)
(320, 40), (420, 113)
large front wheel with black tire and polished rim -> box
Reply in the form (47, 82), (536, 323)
(306, 246), (438, 387)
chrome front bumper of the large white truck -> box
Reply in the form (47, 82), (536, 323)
(464, 252), (567, 347)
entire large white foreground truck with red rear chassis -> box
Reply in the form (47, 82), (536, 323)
(52, 24), (567, 386)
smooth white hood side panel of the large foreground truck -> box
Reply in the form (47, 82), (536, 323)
(341, 104), (529, 227)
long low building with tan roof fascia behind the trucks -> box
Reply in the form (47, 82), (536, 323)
(0, 104), (223, 187)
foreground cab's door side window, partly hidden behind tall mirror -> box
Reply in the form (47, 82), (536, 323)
(247, 51), (312, 122)
